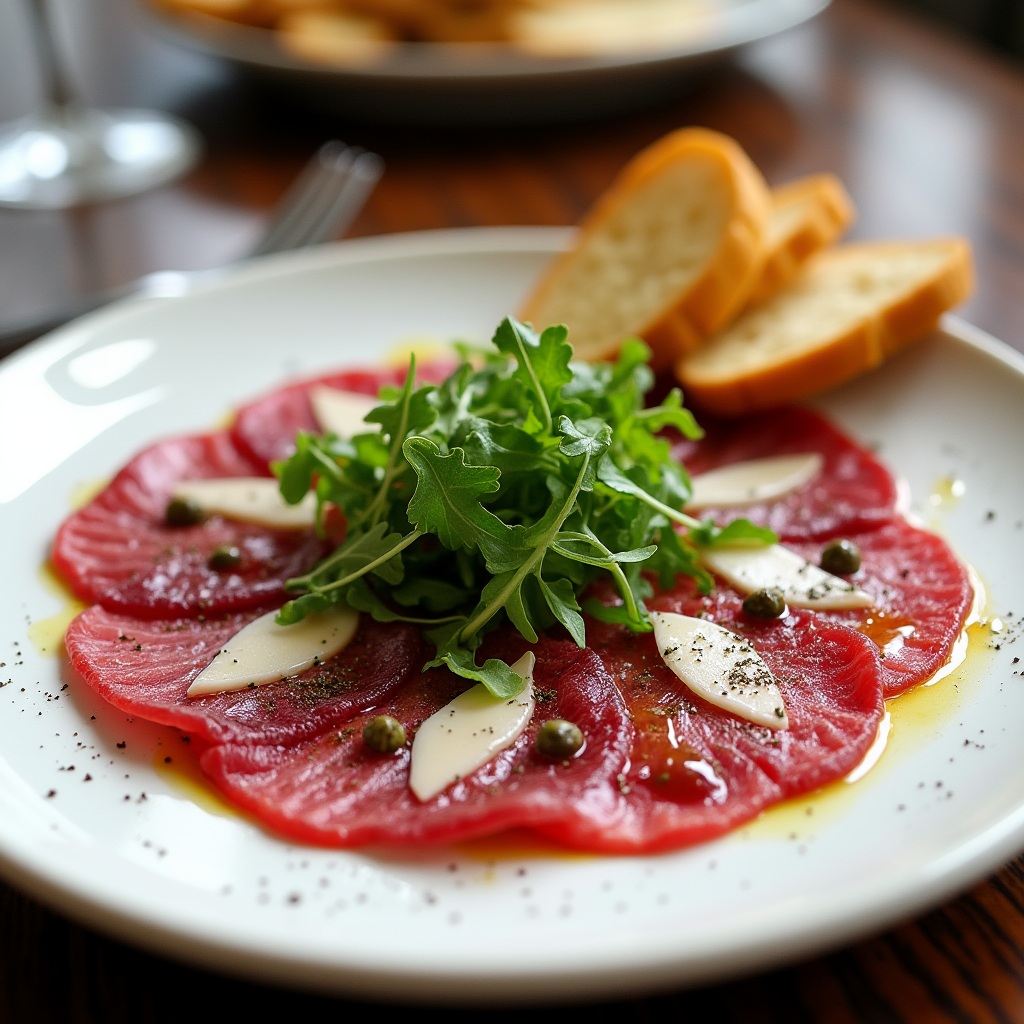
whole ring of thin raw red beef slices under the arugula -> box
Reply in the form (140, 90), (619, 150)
(59, 362), (973, 853)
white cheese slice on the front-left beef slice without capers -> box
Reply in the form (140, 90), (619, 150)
(188, 608), (359, 697)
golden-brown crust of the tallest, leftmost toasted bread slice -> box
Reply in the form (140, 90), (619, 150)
(521, 128), (771, 369)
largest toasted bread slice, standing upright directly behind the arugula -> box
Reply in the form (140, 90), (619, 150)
(522, 128), (771, 367)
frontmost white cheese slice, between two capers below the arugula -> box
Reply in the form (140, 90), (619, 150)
(409, 651), (536, 800)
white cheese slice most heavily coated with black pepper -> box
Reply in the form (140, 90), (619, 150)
(650, 611), (790, 729)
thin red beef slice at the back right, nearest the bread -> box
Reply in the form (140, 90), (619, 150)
(672, 409), (898, 541)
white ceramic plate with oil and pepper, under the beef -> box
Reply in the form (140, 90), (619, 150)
(0, 228), (1024, 1000)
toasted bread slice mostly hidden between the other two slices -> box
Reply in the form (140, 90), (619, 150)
(746, 174), (856, 308)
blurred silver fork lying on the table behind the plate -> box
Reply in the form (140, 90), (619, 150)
(0, 139), (384, 356)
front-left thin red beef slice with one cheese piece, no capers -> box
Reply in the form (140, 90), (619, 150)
(65, 605), (426, 744)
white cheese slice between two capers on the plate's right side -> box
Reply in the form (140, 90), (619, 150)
(700, 544), (874, 608)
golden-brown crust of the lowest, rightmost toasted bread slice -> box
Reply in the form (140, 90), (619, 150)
(676, 239), (974, 416)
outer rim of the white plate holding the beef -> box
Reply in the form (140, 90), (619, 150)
(0, 227), (1024, 1004)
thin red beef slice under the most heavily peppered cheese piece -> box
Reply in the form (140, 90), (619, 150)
(540, 586), (883, 853)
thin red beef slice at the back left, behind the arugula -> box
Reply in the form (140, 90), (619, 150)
(231, 360), (456, 467)
